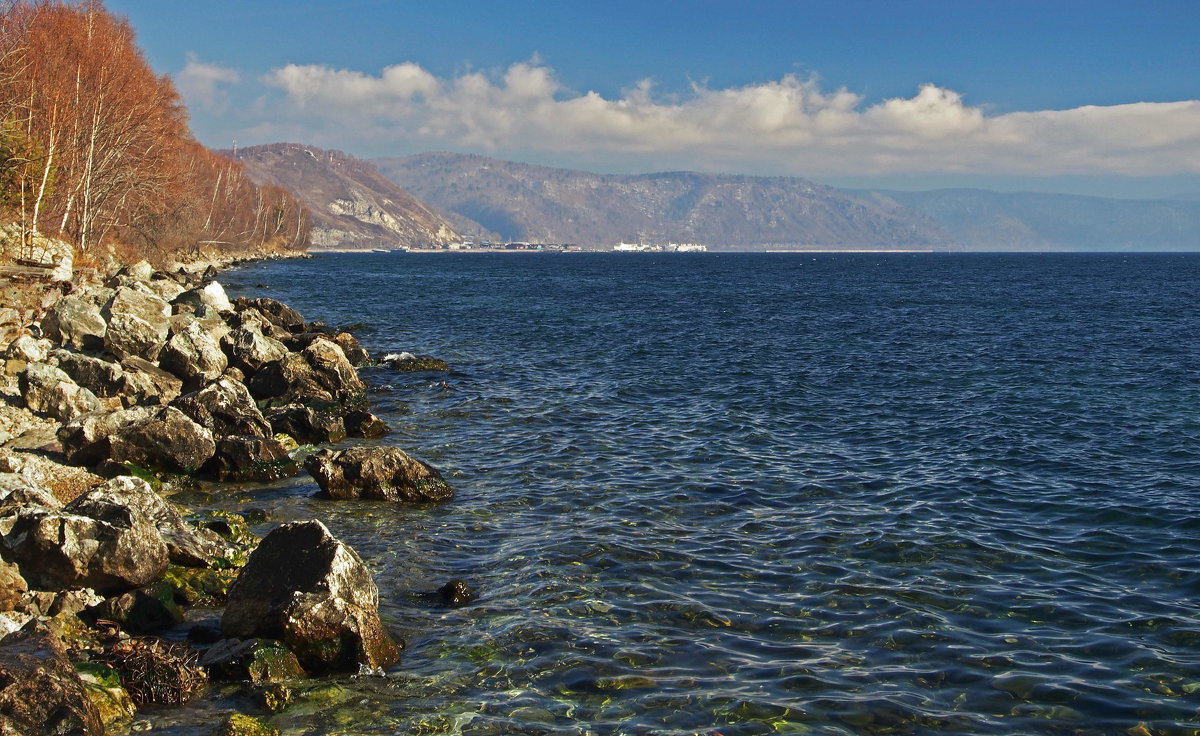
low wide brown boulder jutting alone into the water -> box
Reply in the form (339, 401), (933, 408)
(304, 447), (454, 502)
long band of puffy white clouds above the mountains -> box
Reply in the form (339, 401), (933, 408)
(246, 60), (1200, 176)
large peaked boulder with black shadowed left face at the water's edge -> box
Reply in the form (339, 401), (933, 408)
(221, 521), (400, 672)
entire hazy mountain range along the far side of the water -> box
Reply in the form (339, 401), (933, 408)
(226, 143), (1200, 251)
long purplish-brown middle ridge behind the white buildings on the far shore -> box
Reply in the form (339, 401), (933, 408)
(374, 154), (950, 250)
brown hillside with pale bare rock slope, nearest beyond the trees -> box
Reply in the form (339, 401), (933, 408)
(226, 143), (461, 250)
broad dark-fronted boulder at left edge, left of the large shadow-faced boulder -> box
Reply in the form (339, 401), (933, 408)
(4, 509), (167, 594)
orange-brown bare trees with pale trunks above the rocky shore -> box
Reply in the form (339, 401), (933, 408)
(0, 0), (310, 261)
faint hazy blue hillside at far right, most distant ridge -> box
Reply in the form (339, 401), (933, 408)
(864, 190), (1200, 251)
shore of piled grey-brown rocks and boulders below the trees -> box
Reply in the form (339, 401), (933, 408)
(0, 255), (453, 735)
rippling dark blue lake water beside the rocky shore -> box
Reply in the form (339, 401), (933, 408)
(199, 253), (1200, 736)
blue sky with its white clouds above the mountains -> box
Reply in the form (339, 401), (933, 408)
(106, 0), (1200, 198)
